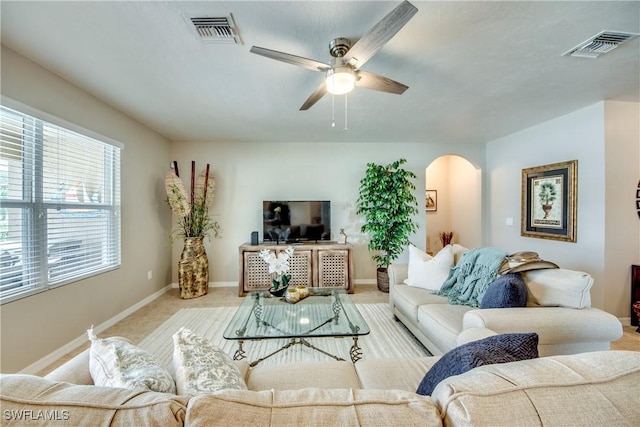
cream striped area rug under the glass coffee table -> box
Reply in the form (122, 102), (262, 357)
(139, 303), (429, 366)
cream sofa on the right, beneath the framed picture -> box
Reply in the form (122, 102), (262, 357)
(388, 245), (622, 356)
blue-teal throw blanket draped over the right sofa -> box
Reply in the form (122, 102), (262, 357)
(438, 248), (507, 307)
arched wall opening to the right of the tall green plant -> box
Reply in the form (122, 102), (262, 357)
(425, 155), (482, 253)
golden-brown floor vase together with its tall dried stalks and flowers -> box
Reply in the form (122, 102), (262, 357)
(165, 162), (221, 299)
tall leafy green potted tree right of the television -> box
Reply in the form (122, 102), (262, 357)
(356, 159), (418, 292)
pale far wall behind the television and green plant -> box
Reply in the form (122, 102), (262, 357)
(172, 142), (484, 284)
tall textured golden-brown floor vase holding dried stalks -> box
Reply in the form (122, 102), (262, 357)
(178, 237), (209, 299)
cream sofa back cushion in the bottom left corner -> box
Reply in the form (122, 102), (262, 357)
(0, 375), (188, 426)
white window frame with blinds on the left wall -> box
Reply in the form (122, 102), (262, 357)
(0, 96), (124, 305)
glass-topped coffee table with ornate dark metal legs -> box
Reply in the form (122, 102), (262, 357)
(223, 288), (369, 366)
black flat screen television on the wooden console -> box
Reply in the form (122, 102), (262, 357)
(262, 200), (331, 243)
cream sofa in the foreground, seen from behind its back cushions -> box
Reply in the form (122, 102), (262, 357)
(0, 351), (640, 427)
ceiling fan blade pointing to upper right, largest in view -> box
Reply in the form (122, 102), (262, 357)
(345, 0), (418, 68)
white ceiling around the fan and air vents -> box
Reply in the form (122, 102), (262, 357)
(0, 0), (640, 143)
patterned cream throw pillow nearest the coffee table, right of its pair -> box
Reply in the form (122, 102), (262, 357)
(173, 328), (247, 397)
